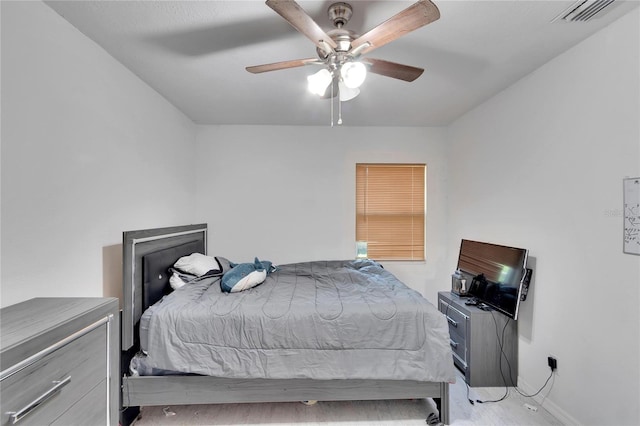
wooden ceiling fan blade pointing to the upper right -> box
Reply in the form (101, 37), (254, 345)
(351, 0), (440, 54)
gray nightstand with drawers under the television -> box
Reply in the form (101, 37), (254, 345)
(438, 291), (518, 387)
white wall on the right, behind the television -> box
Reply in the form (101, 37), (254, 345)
(449, 10), (640, 425)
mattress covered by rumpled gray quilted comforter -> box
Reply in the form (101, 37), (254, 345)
(140, 260), (454, 382)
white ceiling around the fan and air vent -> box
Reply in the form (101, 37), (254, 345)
(47, 0), (639, 126)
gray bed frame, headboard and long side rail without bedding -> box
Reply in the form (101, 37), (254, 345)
(121, 224), (449, 424)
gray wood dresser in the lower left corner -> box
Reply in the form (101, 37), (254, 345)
(0, 298), (120, 426)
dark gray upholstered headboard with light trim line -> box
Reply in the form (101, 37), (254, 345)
(122, 223), (207, 350)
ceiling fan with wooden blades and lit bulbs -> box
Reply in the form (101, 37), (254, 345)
(246, 0), (440, 101)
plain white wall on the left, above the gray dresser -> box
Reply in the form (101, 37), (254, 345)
(0, 1), (195, 306)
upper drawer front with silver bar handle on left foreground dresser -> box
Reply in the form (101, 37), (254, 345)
(0, 323), (107, 425)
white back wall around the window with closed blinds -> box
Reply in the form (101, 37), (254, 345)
(196, 126), (451, 301)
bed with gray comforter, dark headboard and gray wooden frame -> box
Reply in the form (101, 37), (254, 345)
(121, 224), (454, 424)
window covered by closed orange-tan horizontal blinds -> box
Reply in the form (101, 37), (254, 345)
(356, 164), (426, 260)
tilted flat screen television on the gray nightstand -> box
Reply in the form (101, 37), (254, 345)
(458, 240), (529, 320)
